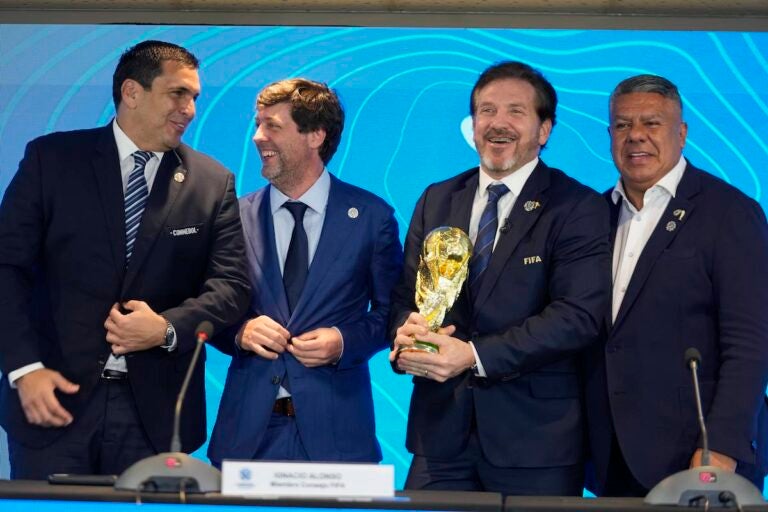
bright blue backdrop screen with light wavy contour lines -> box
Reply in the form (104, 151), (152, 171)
(0, 25), (768, 492)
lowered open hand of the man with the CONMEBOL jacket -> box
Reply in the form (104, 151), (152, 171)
(16, 368), (80, 427)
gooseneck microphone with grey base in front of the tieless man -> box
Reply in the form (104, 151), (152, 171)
(644, 347), (765, 510)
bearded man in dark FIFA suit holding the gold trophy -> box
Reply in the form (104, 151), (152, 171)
(390, 62), (610, 495)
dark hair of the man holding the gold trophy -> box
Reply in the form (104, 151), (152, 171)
(469, 61), (557, 126)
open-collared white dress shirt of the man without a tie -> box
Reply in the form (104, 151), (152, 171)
(611, 157), (686, 321)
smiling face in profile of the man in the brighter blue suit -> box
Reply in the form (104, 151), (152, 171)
(253, 101), (325, 197)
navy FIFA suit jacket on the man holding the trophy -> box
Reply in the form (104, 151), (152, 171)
(390, 162), (610, 467)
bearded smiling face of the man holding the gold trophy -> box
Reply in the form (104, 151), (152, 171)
(472, 78), (552, 179)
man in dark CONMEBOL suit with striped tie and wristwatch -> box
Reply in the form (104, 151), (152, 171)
(0, 41), (250, 479)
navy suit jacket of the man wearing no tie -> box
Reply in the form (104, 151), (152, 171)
(586, 163), (768, 492)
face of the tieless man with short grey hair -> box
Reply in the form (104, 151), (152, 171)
(608, 92), (688, 206)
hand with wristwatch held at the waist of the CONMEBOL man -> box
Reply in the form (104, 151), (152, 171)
(104, 300), (166, 356)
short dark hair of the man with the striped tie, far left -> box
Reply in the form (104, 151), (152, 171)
(112, 41), (200, 109)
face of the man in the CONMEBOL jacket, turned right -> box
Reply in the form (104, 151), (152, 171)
(117, 61), (200, 151)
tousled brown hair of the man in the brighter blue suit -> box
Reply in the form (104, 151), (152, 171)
(256, 78), (344, 164)
